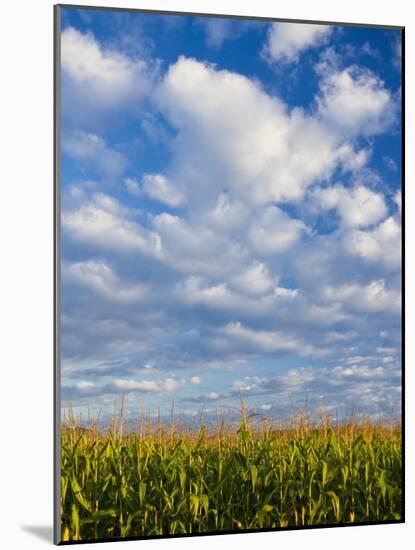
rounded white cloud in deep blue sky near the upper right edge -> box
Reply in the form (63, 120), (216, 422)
(317, 66), (395, 136)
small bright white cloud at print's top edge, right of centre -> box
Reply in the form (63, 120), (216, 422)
(263, 23), (333, 63)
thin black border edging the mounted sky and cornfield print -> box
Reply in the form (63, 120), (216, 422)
(53, 4), (406, 546)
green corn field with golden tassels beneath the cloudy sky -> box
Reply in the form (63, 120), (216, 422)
(61, 415), (402, 541)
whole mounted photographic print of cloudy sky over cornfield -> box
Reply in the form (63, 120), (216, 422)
(55, 5), (404, 544)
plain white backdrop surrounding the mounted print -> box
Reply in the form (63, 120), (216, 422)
(0, 0), (415, 550)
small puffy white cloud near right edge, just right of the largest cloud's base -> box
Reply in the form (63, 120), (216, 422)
(314, 185), (387, 227)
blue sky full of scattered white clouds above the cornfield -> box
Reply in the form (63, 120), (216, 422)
(61, 8), (402, 426)
